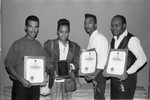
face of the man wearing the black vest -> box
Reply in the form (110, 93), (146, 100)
(111, 18), (126, 37)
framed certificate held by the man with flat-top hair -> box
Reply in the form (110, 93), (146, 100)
(79, 49), (97, 76)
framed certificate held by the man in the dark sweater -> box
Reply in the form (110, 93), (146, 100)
(24, 56), (45, 85)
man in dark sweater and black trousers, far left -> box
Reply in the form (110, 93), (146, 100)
(5, 15), (43, 100)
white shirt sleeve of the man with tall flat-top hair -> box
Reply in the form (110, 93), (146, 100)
(92, 36), (108, 69)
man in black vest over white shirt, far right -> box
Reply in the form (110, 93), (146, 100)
(111, 15), (147, 99)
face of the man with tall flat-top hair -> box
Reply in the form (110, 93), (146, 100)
(84, 17), (97, 35)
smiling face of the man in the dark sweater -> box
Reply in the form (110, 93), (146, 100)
(25, 20), (39, 40)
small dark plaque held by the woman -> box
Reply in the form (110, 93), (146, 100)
(56, 60), (70, 78)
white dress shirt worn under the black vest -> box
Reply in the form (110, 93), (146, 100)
(114, 30), (147, 74)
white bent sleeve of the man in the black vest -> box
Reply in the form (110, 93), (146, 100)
(127, 37), (147, 74)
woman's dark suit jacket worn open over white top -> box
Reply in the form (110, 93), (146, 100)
(44, 38), (80, 77)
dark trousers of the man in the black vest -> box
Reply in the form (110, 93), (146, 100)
(111, 73), (137, 100)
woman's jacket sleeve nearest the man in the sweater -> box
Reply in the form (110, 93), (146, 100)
(44, 41), (54, 75)
